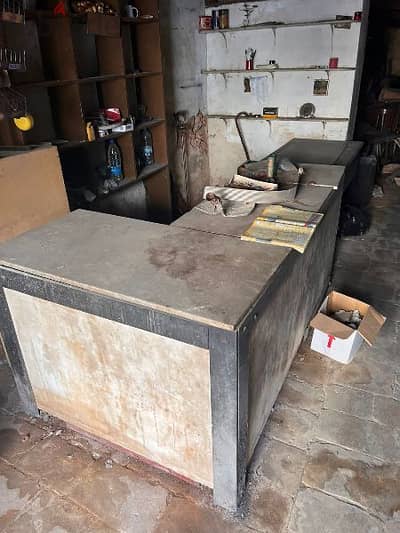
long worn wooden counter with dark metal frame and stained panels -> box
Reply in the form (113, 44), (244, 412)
(0, 166), (343, 509)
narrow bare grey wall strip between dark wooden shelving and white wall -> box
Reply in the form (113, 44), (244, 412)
(160, 0), (209, 211)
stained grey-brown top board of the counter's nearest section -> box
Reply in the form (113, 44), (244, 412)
(0, 210), (290, 330)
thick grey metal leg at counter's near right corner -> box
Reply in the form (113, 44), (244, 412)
(209, 330), (248, 510)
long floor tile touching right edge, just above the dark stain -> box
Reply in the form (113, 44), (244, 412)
(316, 411), (400, 462)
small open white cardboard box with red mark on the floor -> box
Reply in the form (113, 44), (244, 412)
(310, 291), (386, 364)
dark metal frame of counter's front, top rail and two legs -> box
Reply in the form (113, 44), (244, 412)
(0, 266), (249, 510)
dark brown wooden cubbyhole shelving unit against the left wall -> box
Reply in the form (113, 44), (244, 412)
(0, 0), (171, 221)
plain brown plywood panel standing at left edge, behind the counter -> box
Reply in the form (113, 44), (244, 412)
(0, 148), (69, 241)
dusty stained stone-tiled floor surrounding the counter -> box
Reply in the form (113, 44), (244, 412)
(0, 187), (400, 533)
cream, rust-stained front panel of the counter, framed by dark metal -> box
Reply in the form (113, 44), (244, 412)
(6, 289), (213, 487)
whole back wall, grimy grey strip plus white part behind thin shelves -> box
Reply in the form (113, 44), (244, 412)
(160, 0), (368, 197)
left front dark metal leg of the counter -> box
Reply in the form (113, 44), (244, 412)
(0, 288), (39, 416)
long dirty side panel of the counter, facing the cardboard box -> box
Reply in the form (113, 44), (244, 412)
(248, 187), (341, 460)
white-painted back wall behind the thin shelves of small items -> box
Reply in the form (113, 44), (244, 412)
(203, 0), (367, 184)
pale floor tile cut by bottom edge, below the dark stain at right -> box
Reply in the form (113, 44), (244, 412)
(288, 489), (384, 533)
